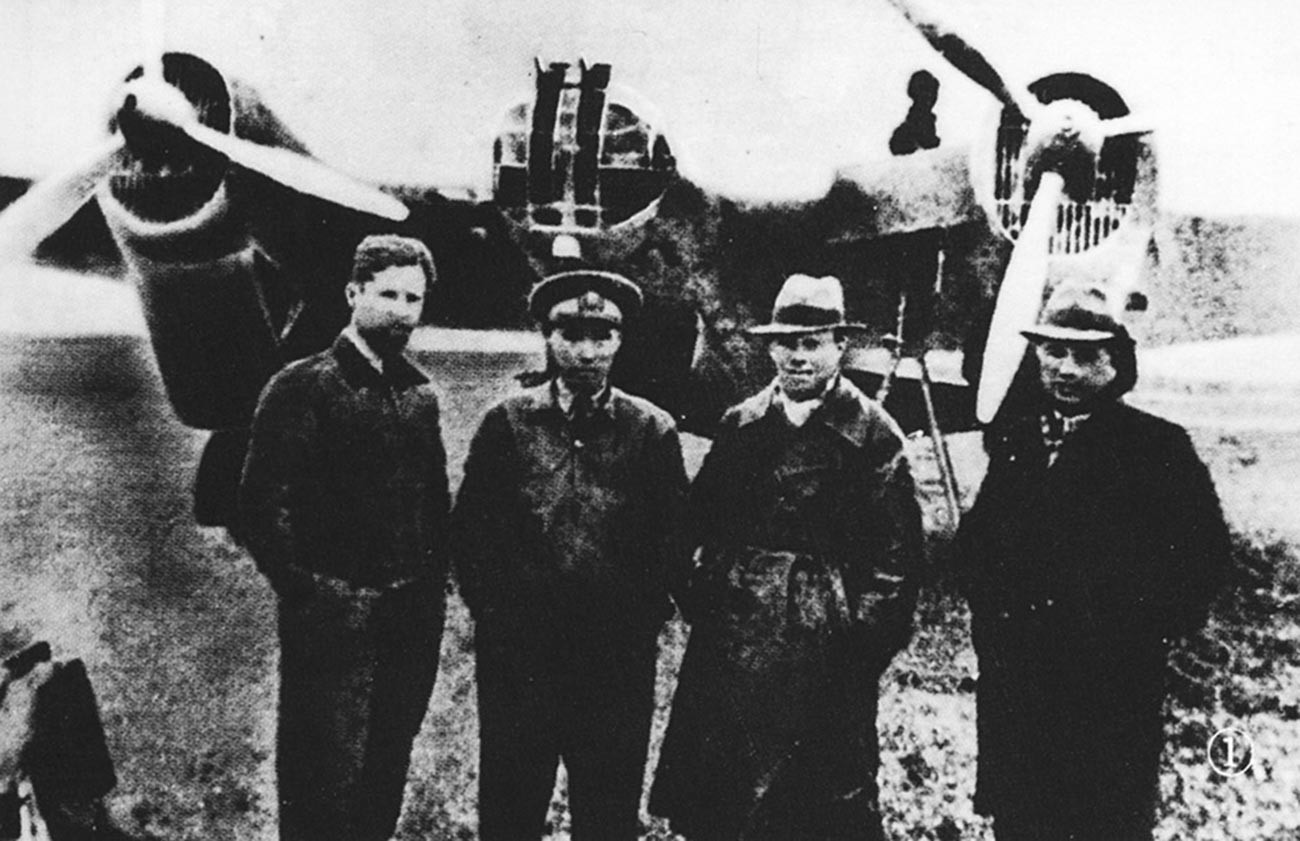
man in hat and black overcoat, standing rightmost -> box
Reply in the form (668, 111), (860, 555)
(958, 286), (1230, 841)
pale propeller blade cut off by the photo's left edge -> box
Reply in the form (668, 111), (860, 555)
(0, 135), (124, 261)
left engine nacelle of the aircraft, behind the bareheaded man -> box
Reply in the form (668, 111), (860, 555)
(96, 53), (319, 429)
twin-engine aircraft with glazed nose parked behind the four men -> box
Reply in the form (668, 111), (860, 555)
(0, 0), (1156, 524)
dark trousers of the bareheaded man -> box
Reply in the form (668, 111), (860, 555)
(276, 581), (445, 841)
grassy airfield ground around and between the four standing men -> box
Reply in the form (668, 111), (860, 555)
(0, 338), (1300, 841)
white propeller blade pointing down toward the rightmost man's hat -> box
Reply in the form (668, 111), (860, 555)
(975, 172), (1065, 424)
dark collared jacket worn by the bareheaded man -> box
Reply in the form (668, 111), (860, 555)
(241, 337), (450, 590)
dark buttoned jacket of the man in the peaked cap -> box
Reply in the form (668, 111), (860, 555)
(454, 382), (686, 620)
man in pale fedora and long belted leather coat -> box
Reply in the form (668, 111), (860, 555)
(650, 274), (922, 841)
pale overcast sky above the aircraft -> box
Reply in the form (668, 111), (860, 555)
(0, 0), (1300, 216)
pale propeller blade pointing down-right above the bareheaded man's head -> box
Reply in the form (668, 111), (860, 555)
(178, 120), (408, 222)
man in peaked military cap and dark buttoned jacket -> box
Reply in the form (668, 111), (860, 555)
(452, 269), (686, 841)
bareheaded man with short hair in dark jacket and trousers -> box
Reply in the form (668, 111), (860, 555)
(239, 235), (449, 841)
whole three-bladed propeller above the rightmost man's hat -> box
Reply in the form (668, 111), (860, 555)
(889, 0), (1152, 424)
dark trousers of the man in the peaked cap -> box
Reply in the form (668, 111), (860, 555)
(476, 611), (658, 841)
